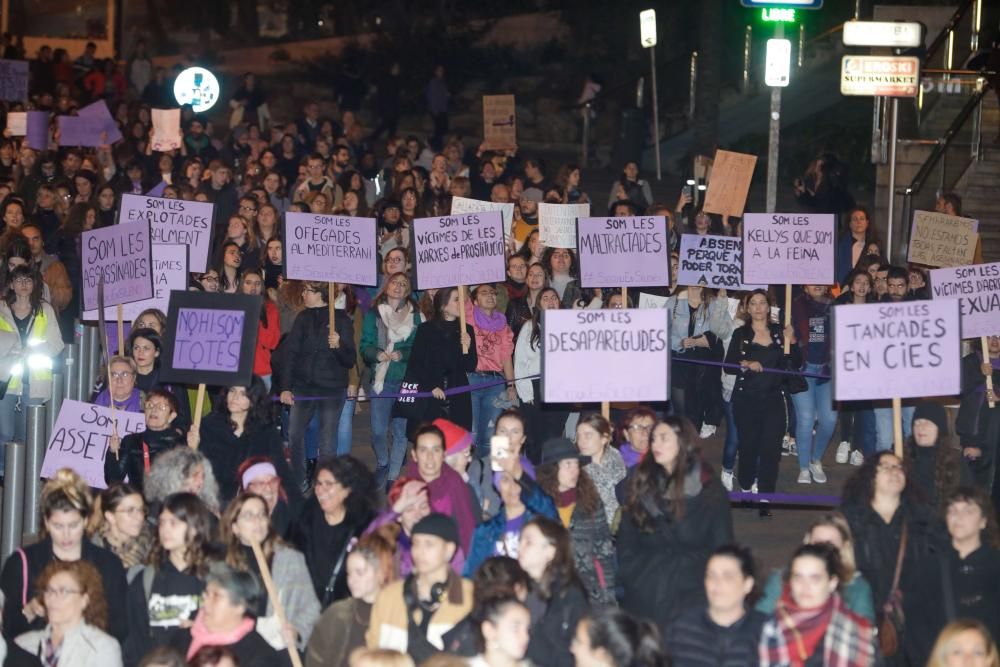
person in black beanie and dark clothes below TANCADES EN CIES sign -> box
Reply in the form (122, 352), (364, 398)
(906, 401), (972, 509)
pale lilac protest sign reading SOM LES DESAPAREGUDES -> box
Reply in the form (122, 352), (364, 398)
(541, 308), (670, 403)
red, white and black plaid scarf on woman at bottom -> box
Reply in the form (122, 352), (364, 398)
(759, 586), (875, 667)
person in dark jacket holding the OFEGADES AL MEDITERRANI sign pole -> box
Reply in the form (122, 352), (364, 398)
(278, 282), (356, 494)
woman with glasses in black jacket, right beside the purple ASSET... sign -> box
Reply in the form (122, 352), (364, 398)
(104, 389), (187, 493)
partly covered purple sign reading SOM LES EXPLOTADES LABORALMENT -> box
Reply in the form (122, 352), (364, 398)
(118, 194), (215, 273)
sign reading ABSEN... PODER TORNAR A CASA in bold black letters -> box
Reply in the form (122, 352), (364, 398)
(677, 234), (759, 290)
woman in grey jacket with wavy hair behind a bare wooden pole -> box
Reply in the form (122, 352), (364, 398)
(221, 493), (319, 650)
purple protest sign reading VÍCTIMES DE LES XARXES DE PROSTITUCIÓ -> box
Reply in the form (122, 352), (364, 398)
(413, 211), (507, 289)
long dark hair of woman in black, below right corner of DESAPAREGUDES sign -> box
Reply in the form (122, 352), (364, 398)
(622, 417), (700, 532)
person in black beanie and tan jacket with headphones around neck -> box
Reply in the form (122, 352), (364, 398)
(366, 514), (472, 662)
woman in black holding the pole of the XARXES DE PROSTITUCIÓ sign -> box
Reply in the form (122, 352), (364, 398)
(393, 287), (479, 431)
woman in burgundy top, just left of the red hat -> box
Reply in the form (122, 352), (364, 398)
(405, 424), (478, 560)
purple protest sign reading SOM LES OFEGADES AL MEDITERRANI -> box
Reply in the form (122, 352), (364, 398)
(284, 212), (378, 285)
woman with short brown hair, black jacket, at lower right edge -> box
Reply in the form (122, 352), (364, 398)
(903, 486), (1000, 665)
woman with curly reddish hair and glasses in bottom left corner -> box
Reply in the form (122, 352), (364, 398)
(15, 561), (122, 667)
